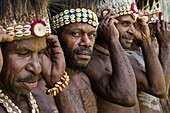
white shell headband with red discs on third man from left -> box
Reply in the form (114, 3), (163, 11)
(101, 2), (139, 19)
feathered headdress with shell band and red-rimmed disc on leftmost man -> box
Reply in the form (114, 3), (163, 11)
(0, 0), (51, 40)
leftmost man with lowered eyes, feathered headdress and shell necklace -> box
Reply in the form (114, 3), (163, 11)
(0, 0), (65, 113)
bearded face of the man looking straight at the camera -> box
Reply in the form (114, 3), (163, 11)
(59, 23), (96, 71)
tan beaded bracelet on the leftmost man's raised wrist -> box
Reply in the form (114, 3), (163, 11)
(47, 71), (69, 96)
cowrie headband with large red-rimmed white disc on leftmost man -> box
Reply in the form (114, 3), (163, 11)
(3, 20), (51, 40)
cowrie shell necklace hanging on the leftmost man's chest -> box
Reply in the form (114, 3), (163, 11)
(0, 89), (39, 113)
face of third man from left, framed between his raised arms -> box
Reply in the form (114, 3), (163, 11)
(116, 15), (136, 49)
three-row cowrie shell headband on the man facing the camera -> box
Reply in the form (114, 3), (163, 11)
(52, 8), (99, 29)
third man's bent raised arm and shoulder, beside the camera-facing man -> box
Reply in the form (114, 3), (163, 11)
(86, 12), (136, 106)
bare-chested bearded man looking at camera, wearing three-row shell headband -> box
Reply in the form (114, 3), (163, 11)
(49, 0), (98, 113)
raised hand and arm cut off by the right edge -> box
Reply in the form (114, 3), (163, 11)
(156, 20), (170, 113)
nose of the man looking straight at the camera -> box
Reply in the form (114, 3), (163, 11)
(79, 34), (94, 47)
